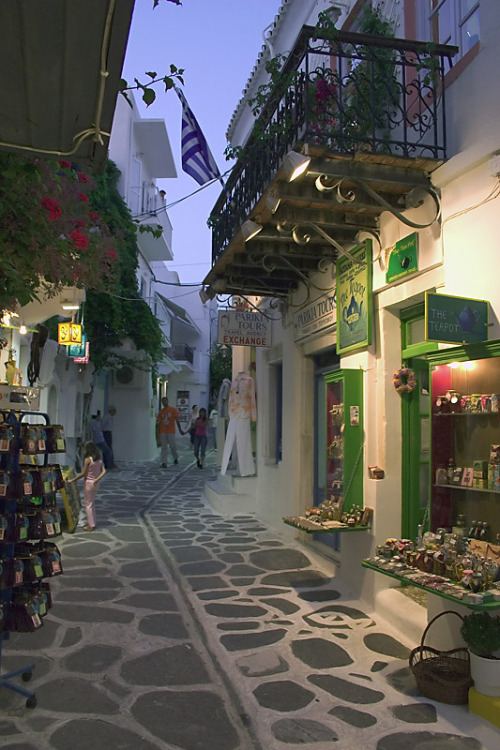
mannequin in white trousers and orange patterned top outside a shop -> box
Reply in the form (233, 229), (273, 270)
(221, 371), (257, 477)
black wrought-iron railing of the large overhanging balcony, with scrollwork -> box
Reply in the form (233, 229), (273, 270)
(211, 27), (456, 264)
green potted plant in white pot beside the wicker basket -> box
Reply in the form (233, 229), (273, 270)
(460, 612), (500, 697)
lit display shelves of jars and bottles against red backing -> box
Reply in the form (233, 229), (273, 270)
(431, 356), (500, 538)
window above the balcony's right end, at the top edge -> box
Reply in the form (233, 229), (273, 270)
(424, 0), (479, 60)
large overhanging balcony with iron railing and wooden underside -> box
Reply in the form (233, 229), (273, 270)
(204, 27), (457, 297)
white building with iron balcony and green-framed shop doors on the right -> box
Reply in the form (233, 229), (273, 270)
(205, 0), (500, 637)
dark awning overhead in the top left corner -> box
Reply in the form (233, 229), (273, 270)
(0, 0), (134, 171)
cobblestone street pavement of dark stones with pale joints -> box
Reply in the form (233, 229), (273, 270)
(0, 447), (498, 750)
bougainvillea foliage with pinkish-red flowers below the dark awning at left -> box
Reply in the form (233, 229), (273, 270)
(0, 153), (118, 309)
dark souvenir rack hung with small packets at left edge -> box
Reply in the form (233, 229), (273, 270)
(0, 410), (65, 708)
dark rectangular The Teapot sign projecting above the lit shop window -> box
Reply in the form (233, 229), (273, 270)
(425, 292), (489, 344)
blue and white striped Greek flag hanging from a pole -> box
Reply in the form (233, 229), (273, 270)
(175, 87), (224, 185)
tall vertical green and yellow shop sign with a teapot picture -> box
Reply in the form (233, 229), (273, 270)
(337, 240), (372, 354)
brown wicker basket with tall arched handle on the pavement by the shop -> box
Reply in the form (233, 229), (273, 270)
(410, 610), (472, 705)
